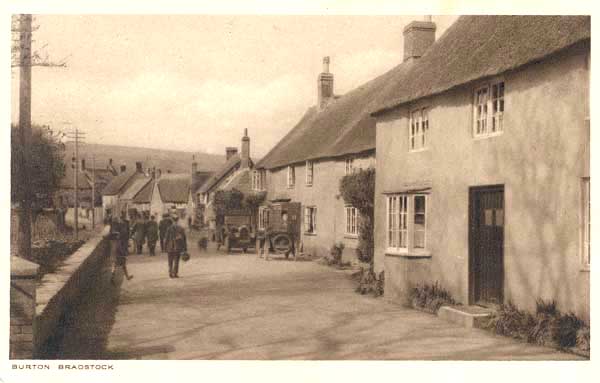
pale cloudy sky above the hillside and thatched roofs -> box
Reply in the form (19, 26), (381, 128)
(12, 15), (457, 158)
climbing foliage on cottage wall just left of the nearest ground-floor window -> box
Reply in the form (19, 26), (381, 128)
(340, 168), (375, 264)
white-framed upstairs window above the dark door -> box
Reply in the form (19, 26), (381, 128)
(473, 79), (506, 139)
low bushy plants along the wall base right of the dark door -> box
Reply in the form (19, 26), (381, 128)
(486, 299), (589, 351)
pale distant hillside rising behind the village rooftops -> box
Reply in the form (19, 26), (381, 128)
(65, 143), (225, 173)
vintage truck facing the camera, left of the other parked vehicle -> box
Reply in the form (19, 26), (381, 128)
(219, 209), (256, 253)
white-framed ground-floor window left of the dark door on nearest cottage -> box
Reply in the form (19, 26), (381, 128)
(385, 193), (429, 255)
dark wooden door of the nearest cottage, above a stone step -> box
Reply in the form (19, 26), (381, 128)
(469, 186), (504, 306)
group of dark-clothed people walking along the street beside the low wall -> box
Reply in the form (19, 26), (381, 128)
(109, 212), (187, 282)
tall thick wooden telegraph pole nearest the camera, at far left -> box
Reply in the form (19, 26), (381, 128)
(18, 15), (31, 257)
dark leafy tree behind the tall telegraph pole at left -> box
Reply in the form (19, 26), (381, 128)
(10, 125), (65, 204)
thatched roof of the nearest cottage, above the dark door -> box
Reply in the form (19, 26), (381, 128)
(372, 16), (590, 114)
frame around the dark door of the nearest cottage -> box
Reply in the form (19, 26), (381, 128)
(467, 184), (506, 305)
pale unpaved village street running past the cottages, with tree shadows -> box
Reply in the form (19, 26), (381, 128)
(45, 236), (578, 360)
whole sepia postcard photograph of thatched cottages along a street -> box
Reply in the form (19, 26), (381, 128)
(0, 0), (592, 382)
